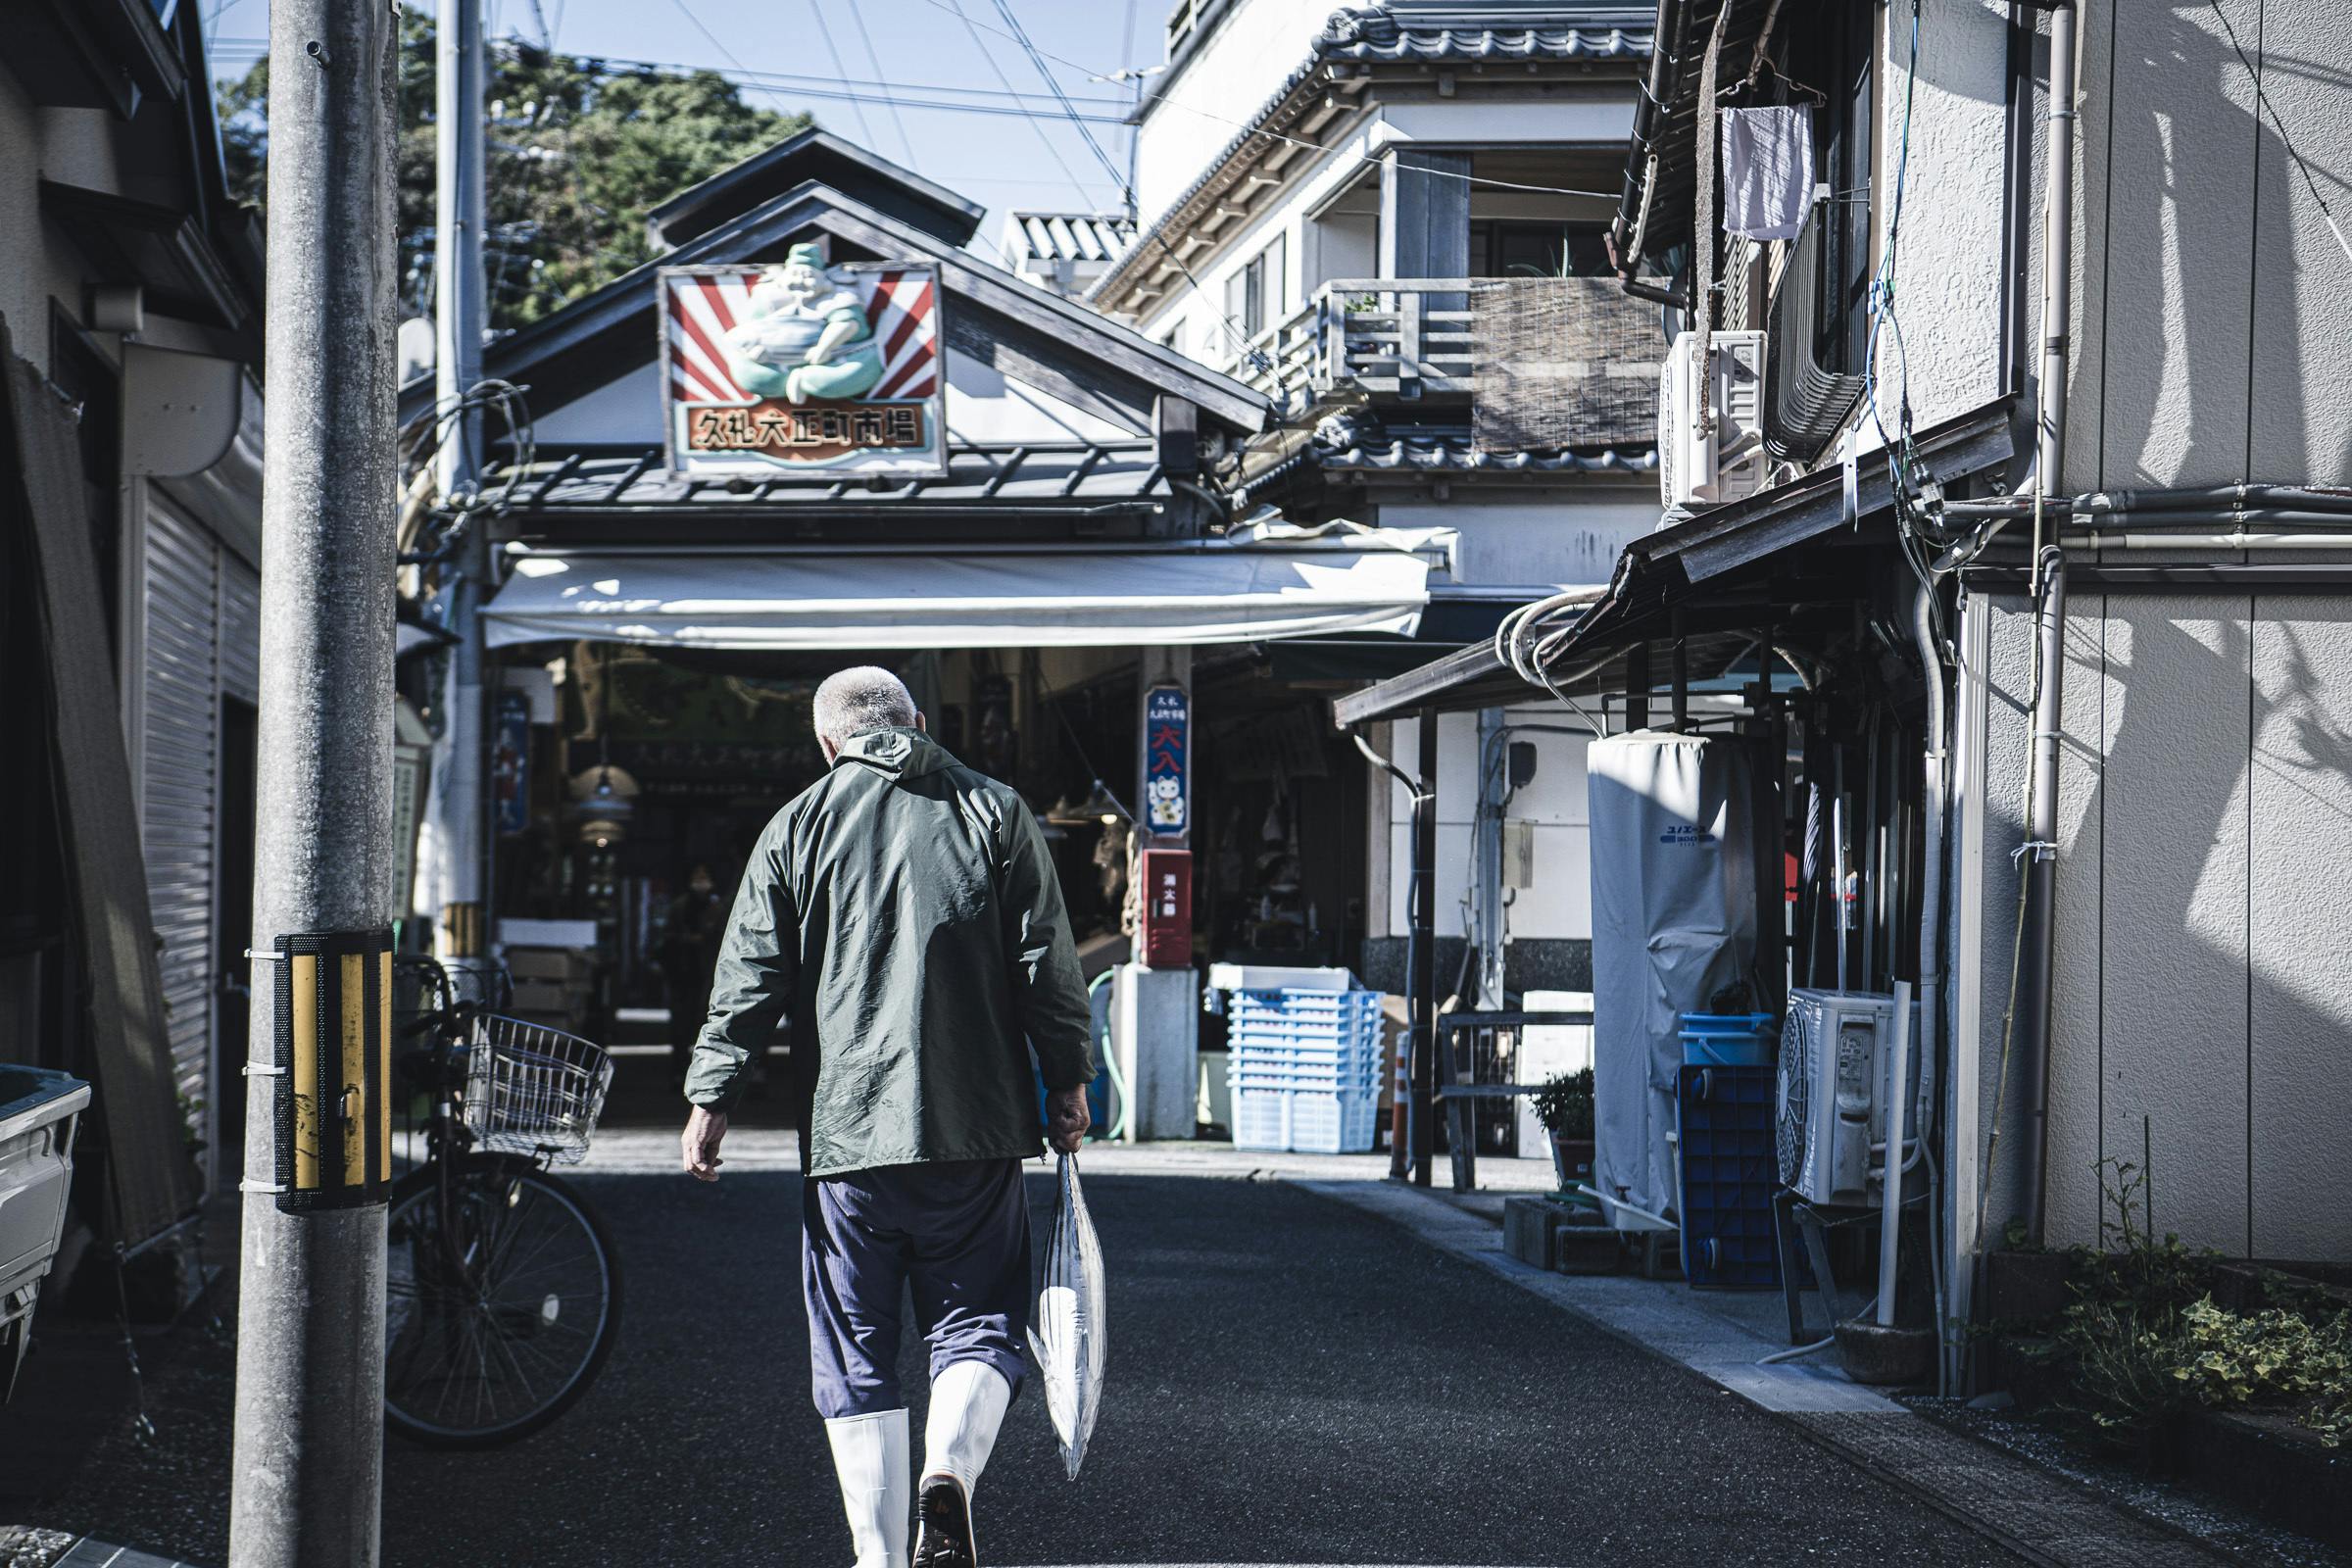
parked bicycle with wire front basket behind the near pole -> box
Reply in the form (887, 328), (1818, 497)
(383, 959), (621, 1448)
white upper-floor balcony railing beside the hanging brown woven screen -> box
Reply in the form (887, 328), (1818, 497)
(1235, 277), (1665, 414)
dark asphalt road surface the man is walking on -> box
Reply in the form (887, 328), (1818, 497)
(41, 1166), (2013, 1568)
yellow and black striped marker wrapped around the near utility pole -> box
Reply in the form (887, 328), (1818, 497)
(275, 926), (393, 1213)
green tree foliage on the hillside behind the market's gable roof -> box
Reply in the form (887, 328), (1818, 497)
(217, 12), (811, 329)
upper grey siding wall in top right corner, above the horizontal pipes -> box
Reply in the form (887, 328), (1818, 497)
(2070, 0), (2352, 489)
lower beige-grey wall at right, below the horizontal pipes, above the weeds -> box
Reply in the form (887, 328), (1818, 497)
(1962, 595), (2352, 1257)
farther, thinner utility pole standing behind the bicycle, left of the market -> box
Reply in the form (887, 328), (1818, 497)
(430, 0), (489, 959)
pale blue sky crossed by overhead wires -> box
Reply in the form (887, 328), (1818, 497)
(198, 0), (1166, 252)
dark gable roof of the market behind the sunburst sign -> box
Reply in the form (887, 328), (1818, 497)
(400, 181), (1272, 435)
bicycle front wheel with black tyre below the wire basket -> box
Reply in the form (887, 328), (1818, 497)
(383, 1156), (621, 1448)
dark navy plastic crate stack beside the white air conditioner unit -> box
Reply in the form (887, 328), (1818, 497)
(1675, 1065), (1781, 1291)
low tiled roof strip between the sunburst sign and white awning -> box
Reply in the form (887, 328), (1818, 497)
(492, 442), (1171, 514)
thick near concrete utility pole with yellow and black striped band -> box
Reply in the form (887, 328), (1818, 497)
(228, 0), (400, 1568)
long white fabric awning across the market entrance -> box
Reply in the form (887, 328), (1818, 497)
(484, 529), (1453, 649)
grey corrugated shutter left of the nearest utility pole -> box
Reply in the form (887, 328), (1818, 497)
(139, 510), (221, 1126)
